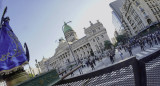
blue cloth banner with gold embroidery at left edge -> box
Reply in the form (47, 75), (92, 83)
(0, 19), (27, 73)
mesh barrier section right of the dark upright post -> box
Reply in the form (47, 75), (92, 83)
(140, 50), (160, 86)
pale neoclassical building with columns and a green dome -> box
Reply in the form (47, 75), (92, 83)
(40, 21), (109, 71)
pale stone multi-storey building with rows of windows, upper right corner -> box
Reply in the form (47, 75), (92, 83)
(120, 0), (160, 36)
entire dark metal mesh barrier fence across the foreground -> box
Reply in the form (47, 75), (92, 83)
(56, 50), (160, 86)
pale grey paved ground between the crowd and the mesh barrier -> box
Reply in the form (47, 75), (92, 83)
(66, 44), (160, 79)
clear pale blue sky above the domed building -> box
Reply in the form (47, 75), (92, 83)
(0, 0), (114, 67)
